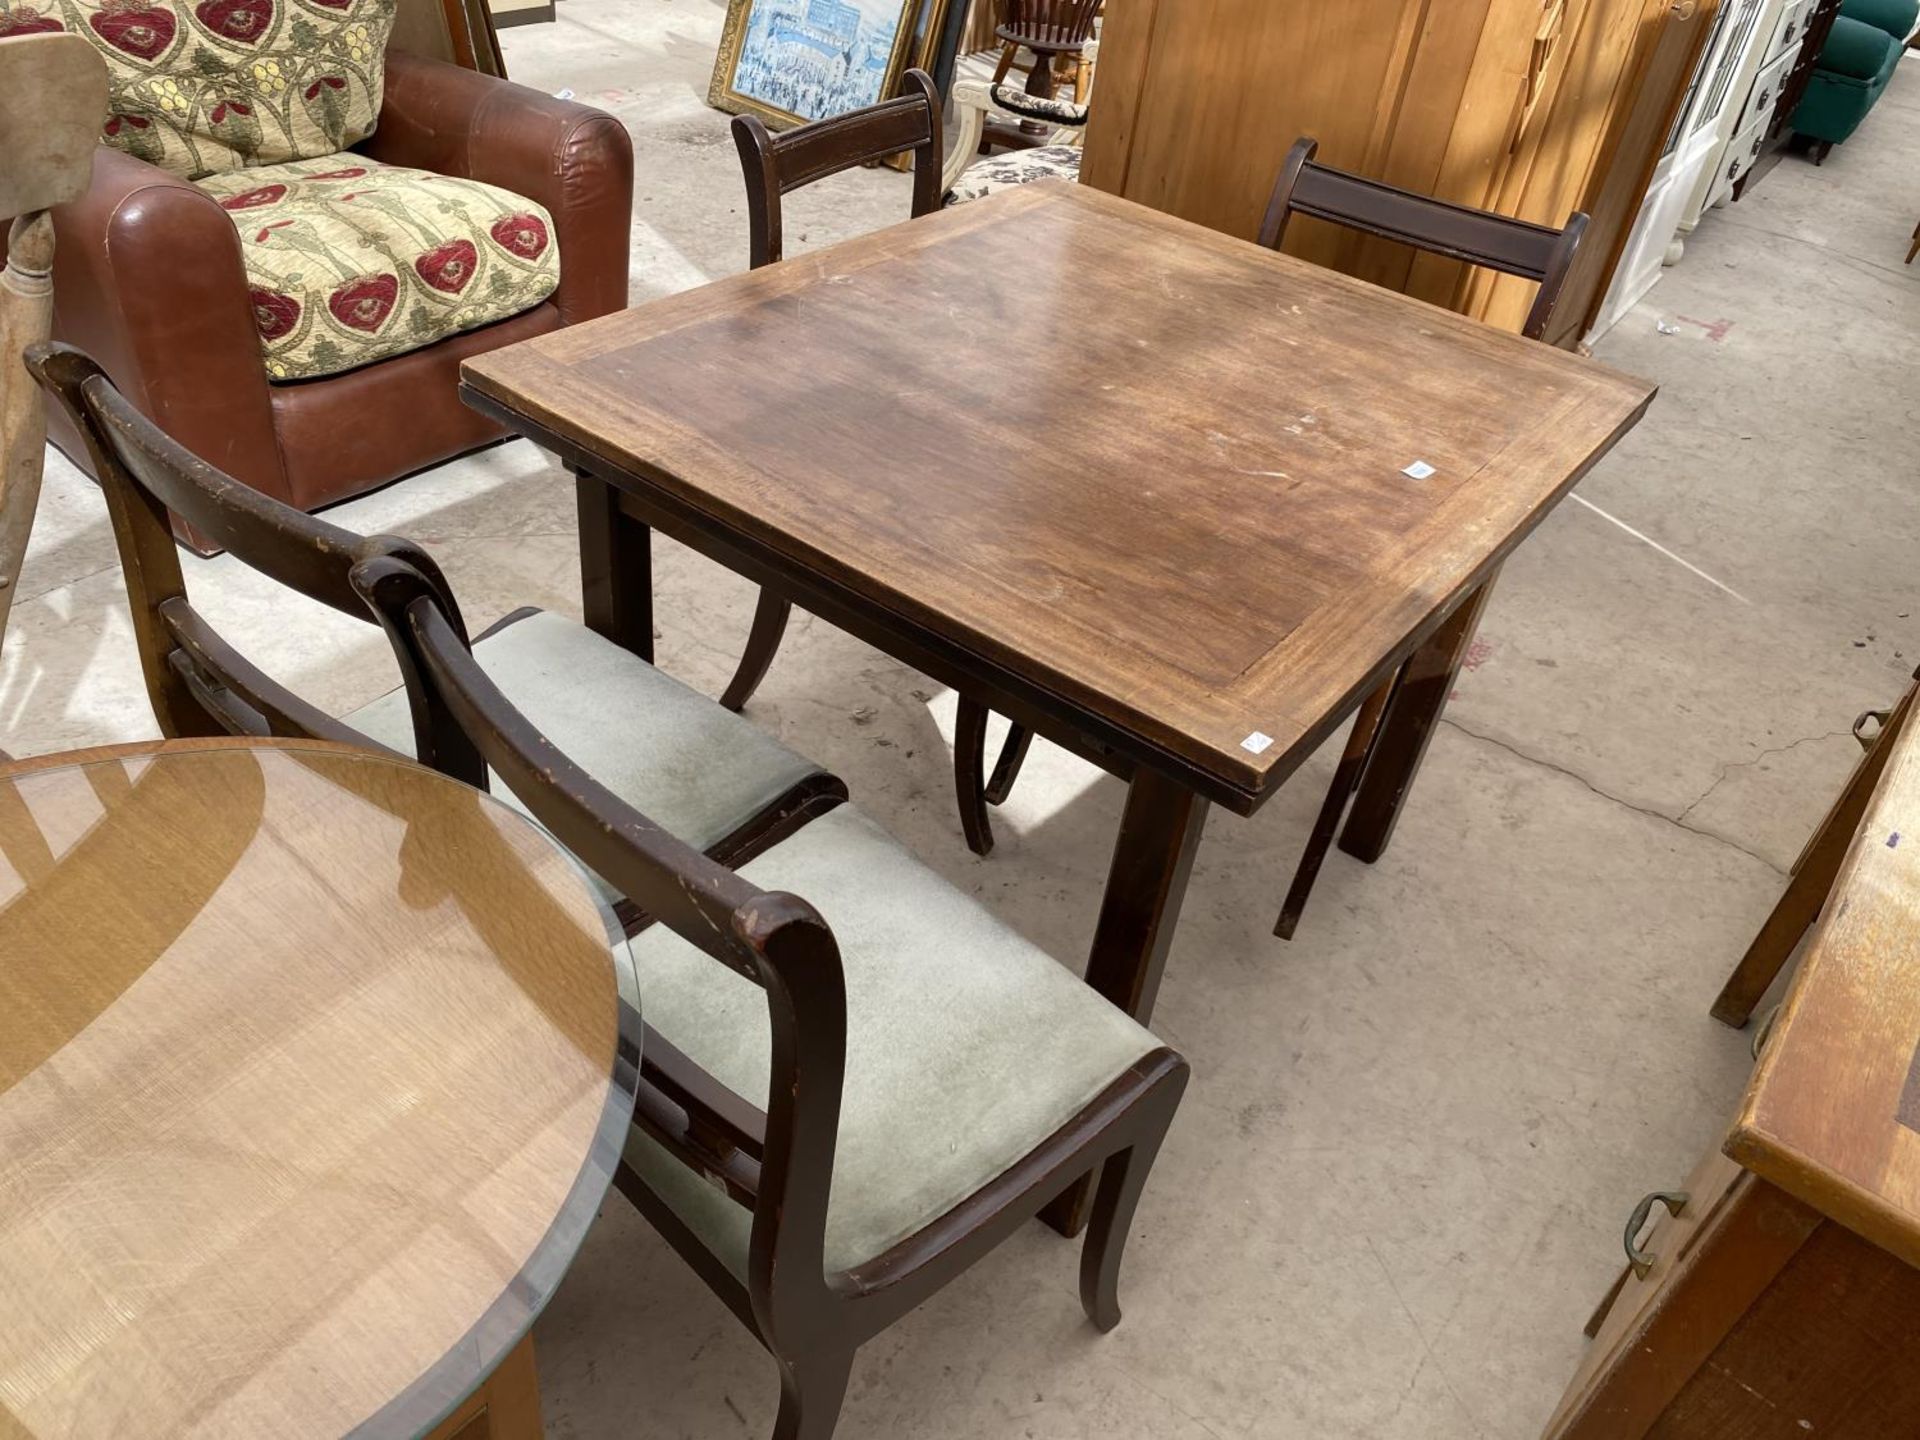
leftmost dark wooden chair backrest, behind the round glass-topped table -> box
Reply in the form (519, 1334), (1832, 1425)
(27, 344), (486, 787)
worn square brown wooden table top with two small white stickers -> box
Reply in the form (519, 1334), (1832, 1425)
(463, 182), (1653, 808)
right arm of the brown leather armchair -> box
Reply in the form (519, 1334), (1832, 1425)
(359, 50), (634, 324)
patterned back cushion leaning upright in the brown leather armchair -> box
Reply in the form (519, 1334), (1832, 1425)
(0, 0), (396, 180)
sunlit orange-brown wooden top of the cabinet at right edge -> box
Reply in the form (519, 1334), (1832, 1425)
(1726, 710), (1920, 1265)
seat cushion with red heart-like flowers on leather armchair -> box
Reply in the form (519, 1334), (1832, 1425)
(200, 154), (561, 380)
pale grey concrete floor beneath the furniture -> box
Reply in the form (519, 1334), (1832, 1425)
(0, 0), (1920, 1440)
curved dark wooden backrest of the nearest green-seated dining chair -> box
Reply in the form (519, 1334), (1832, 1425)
(353, 555), (847, 1325)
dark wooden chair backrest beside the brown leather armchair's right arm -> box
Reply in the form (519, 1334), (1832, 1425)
(733, 69), (947, 269)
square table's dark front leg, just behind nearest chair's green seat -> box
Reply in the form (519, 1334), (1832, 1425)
(1041, 766), (1208, 1235)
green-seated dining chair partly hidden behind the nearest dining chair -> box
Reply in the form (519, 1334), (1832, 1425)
(27, 344), (847, 927)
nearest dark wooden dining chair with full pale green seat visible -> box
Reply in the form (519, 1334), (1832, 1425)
(353, 555), (1187, 1440)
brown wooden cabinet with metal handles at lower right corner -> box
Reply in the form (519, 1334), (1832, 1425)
(1546, 687), (1920, 1440)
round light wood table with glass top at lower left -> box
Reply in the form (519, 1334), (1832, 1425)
(0, 741), (639, 1440)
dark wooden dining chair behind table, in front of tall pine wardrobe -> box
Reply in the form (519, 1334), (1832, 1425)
(1260, 138), (1588, 939)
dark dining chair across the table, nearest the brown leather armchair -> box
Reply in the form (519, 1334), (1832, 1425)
(720, 69), (1031, 854)
